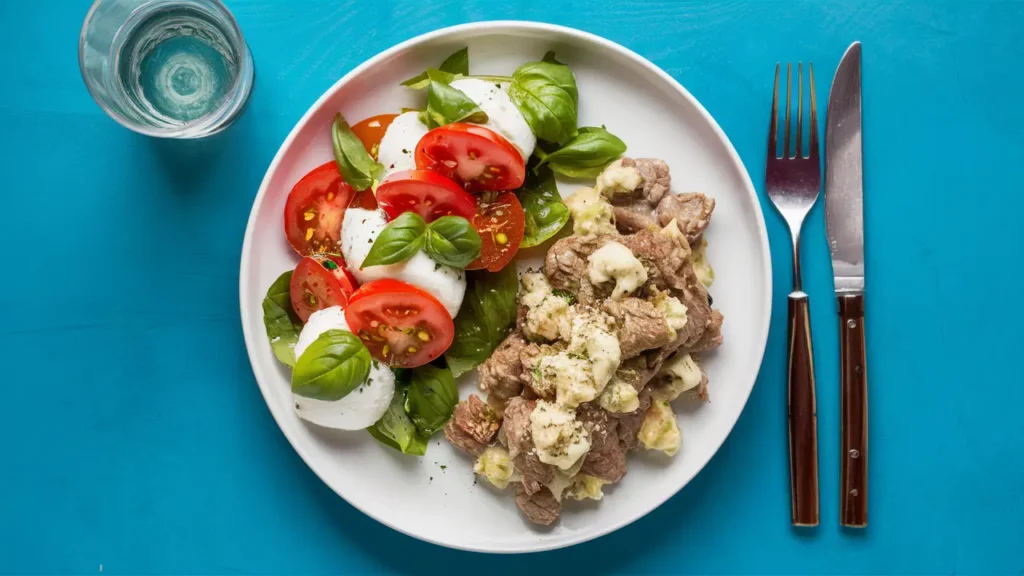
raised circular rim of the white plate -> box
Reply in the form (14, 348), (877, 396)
(239, 19), (772, 553)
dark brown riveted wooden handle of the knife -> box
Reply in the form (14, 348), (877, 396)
(839, 294), (867, 528)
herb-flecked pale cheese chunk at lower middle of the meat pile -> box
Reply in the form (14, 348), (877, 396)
(529, 400), (590, 470)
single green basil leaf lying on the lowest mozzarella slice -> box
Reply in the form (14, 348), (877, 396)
(292, 330), (370, 401)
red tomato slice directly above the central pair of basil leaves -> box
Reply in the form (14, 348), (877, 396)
(377, 170), (476, 222)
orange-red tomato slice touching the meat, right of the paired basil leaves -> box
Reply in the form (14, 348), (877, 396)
(466, 192), (526, 272)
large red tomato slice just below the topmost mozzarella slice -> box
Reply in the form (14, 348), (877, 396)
(416, 122), (526, 191)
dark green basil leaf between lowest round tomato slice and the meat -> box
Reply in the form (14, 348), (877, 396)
(444, 265), (519, 378)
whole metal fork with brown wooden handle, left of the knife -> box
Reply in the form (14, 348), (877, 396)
(765, 63), (821, 526)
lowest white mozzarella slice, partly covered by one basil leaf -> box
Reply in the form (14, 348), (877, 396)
(292, 306), (394, 430)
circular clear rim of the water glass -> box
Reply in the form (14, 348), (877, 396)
(78, 0), (252, 138)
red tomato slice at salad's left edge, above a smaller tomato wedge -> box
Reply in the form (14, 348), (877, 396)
(285, 160), (355, 256)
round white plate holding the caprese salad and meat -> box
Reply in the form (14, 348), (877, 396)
(240, 22), (771, 552)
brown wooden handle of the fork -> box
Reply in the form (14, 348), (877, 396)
(788, 290), (818, 526)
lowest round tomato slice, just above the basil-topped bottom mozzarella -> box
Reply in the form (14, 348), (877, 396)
(345, 279), (455, 368)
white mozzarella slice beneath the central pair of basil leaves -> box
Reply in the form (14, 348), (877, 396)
(341, 208), (466, 318)
